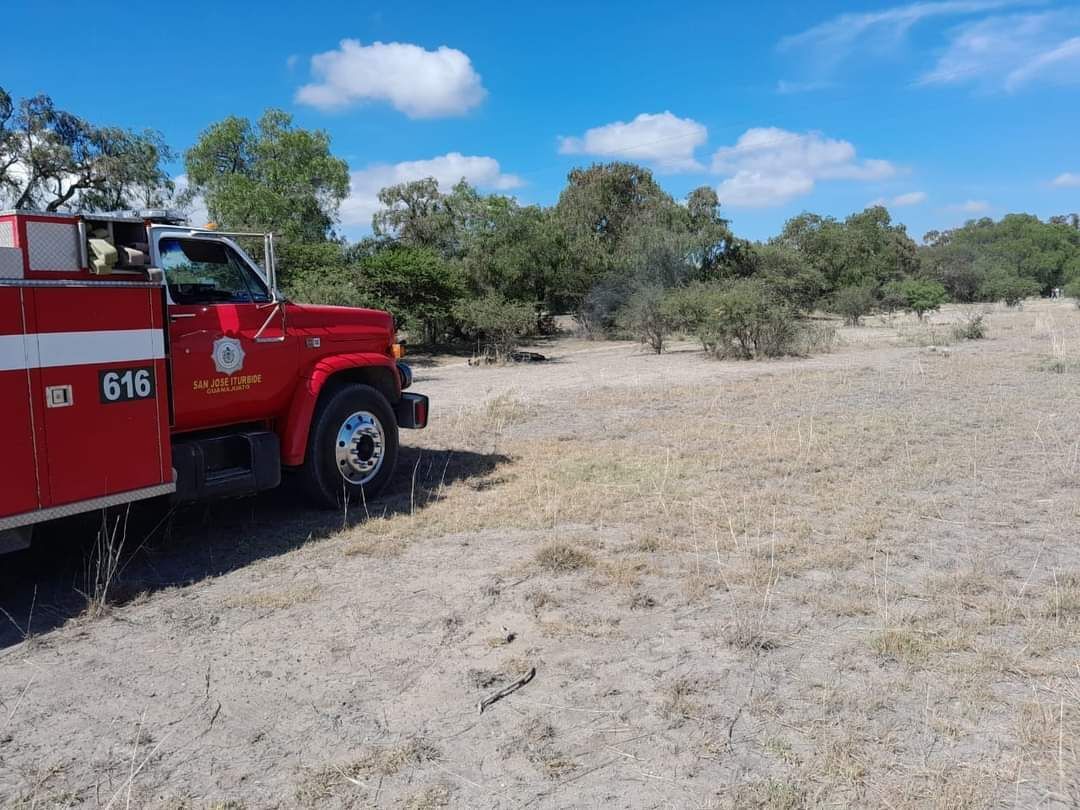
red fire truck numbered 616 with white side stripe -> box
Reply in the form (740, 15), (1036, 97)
(0, 212), (428, 552)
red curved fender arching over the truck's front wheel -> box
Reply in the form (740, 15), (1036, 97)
(281, 352), (401, 467)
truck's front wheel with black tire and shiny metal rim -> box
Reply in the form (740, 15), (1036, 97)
(300, 383), (397, 509)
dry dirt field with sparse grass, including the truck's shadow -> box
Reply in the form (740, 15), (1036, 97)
(0, 301), (1080, 810)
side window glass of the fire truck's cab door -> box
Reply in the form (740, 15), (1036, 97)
(158, 237), (270, 303)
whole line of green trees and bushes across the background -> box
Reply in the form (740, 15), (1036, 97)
(0, 89), (1080, 356)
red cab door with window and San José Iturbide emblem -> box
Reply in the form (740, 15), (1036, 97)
(154, 231), (298, 431)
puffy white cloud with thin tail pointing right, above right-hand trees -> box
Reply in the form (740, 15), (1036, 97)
(712, 127), (896, 207)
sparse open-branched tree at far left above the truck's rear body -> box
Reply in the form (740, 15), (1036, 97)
(0, 87), (174, 211)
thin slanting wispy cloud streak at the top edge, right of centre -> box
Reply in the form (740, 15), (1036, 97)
(778, 0), (1024, 64)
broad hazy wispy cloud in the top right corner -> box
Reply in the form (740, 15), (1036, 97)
(919, 11), (1080, 91)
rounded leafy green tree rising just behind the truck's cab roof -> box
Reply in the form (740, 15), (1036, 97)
(184, 109), (349, 242)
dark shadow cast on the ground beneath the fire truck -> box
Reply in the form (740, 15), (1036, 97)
(0, 446), (509, 650)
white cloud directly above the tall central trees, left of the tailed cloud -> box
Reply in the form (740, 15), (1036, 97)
(558, 111), (708, 172)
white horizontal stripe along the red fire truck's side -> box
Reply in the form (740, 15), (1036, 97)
(0, 329), (165, 372)
